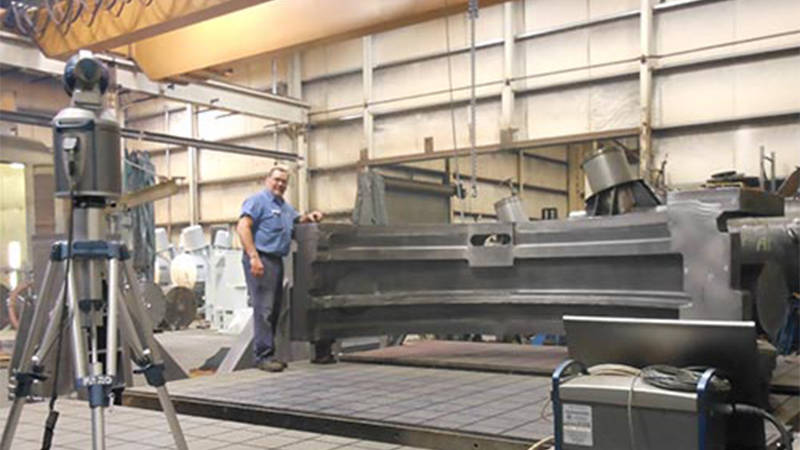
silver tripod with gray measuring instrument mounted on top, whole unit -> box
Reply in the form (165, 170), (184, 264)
(0, 51), (187, 450)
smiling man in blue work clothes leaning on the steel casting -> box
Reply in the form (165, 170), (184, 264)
(236, 166), (322, 372)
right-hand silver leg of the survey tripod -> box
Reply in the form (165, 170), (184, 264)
(119, 259), (188, 450)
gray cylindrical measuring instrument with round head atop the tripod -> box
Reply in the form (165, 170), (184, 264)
(52, 50), (122, 207)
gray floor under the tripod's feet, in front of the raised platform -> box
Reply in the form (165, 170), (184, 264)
(0, 399), (424, 450)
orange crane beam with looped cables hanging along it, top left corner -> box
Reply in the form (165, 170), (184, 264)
(21, 0), (263, 59)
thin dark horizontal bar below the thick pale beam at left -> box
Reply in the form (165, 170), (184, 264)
(0, 110), (302, 161)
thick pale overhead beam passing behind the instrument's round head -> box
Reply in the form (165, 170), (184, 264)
(0, 33), (309, 123)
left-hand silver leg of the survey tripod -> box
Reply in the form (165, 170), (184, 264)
(0, 261), (63, 450)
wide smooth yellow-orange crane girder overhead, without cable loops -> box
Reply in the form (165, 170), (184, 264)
(129, 0), (502, 79)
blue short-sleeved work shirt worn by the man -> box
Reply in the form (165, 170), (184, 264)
(239, 189), (300, 256)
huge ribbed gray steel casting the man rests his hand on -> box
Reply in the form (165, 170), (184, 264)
(292, 197), (764, 341)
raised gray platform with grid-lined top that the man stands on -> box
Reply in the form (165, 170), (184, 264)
(123, 363), (553, 450)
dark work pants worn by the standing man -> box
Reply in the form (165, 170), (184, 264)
(242, 253), (283, 363)
